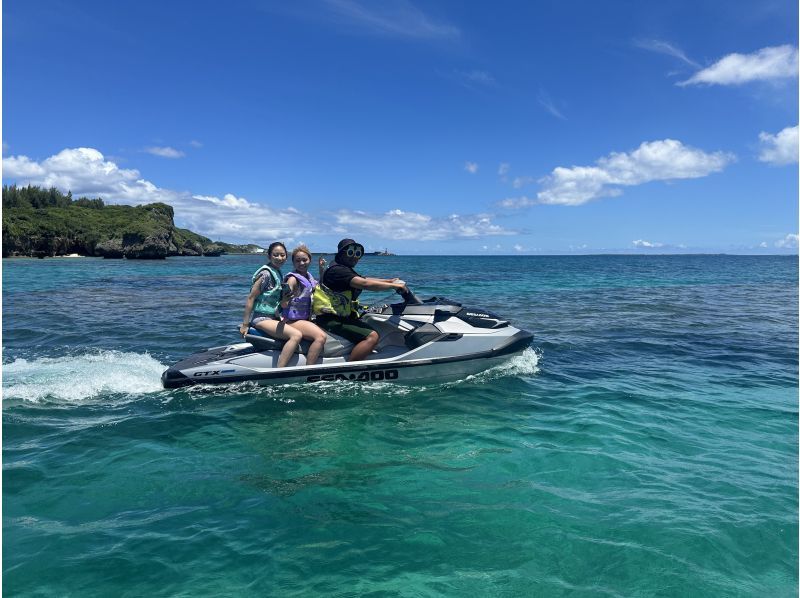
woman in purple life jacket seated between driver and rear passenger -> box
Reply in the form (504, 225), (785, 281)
(281, 245), (328, 365)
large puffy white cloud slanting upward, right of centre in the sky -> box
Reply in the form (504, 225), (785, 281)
(524, 139), (735, 207)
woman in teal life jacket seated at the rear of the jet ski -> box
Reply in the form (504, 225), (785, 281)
(239, 242), (303, 368)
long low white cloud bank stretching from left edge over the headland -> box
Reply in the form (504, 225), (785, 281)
(3, 148), (513, 242)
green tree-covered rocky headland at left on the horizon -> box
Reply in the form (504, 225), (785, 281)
(3, 185), (260, 259)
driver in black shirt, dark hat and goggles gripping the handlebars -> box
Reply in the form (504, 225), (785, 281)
(313, 239), (406, 361)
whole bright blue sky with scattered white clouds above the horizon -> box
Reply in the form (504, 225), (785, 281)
(2, 0), (798, 254)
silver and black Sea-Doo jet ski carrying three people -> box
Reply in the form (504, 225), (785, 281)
(161, 290), (533, 388)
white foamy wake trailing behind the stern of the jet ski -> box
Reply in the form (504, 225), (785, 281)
(3, 351), (166, 403)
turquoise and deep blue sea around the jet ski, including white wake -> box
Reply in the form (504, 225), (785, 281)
(3, 256), (798, 596)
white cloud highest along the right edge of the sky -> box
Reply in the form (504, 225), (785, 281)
(678, 44), (797, 86)
